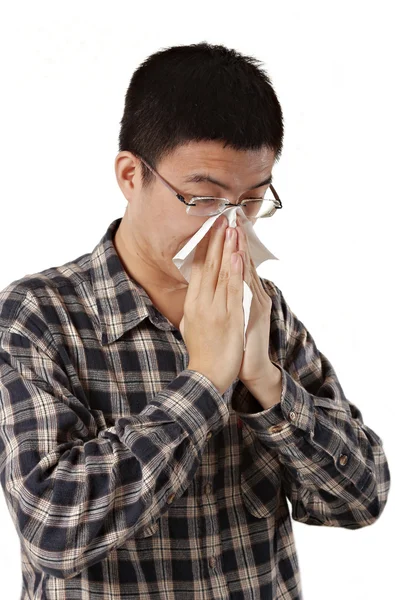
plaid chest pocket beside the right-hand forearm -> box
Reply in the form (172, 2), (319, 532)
(240, 426), (282, 518)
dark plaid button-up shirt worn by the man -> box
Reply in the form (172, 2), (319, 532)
(0, 219), (390, 600)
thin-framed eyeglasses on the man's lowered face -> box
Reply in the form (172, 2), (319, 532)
(140, 157), (283, 219)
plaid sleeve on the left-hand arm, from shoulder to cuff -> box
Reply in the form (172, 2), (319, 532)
(0, 292), (229, 579)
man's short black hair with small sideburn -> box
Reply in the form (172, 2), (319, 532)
(119, 42), (284, 188)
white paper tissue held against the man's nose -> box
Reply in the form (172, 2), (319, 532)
(173, 206), (278, 350)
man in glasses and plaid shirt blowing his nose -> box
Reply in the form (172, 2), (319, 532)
(0, 43), (390, 600)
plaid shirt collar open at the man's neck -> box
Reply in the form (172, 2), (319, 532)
(90, 217), (174, 345)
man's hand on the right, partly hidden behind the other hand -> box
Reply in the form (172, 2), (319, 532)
(236, 217), (276, 387)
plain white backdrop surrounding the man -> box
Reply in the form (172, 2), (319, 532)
(0, 0), (395, 600)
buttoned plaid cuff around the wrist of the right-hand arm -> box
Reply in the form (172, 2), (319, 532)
(232, 363), (315, 447)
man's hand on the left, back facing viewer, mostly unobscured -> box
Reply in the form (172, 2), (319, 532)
(180, 216), (248, 395)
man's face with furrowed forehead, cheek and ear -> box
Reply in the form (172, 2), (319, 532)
(115, 141), (275, 285)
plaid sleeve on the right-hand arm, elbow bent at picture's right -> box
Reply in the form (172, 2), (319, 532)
(235, 280), (390, 529)
